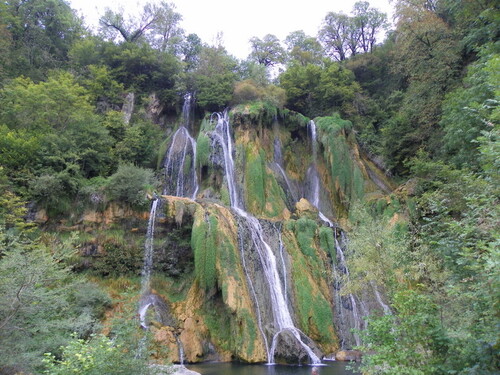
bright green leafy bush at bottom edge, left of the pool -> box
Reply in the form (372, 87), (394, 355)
(43, 335), (153, 375)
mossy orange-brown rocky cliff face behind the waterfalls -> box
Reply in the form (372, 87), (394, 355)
(40, 106), (392, 363)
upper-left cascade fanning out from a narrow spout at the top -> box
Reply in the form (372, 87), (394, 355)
(163, 93), (199, 199)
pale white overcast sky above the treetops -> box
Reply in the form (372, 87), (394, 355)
(69, 0), (392, 59)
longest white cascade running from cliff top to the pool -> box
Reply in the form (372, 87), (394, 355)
(210, 111), (320, 364)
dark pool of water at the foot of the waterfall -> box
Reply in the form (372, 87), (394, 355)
(186, 362), (359, 375)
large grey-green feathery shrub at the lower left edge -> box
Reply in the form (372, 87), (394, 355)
(0, 227), (109, 371)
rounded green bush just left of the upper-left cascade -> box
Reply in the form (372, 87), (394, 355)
(106, 164), (155, 208)
